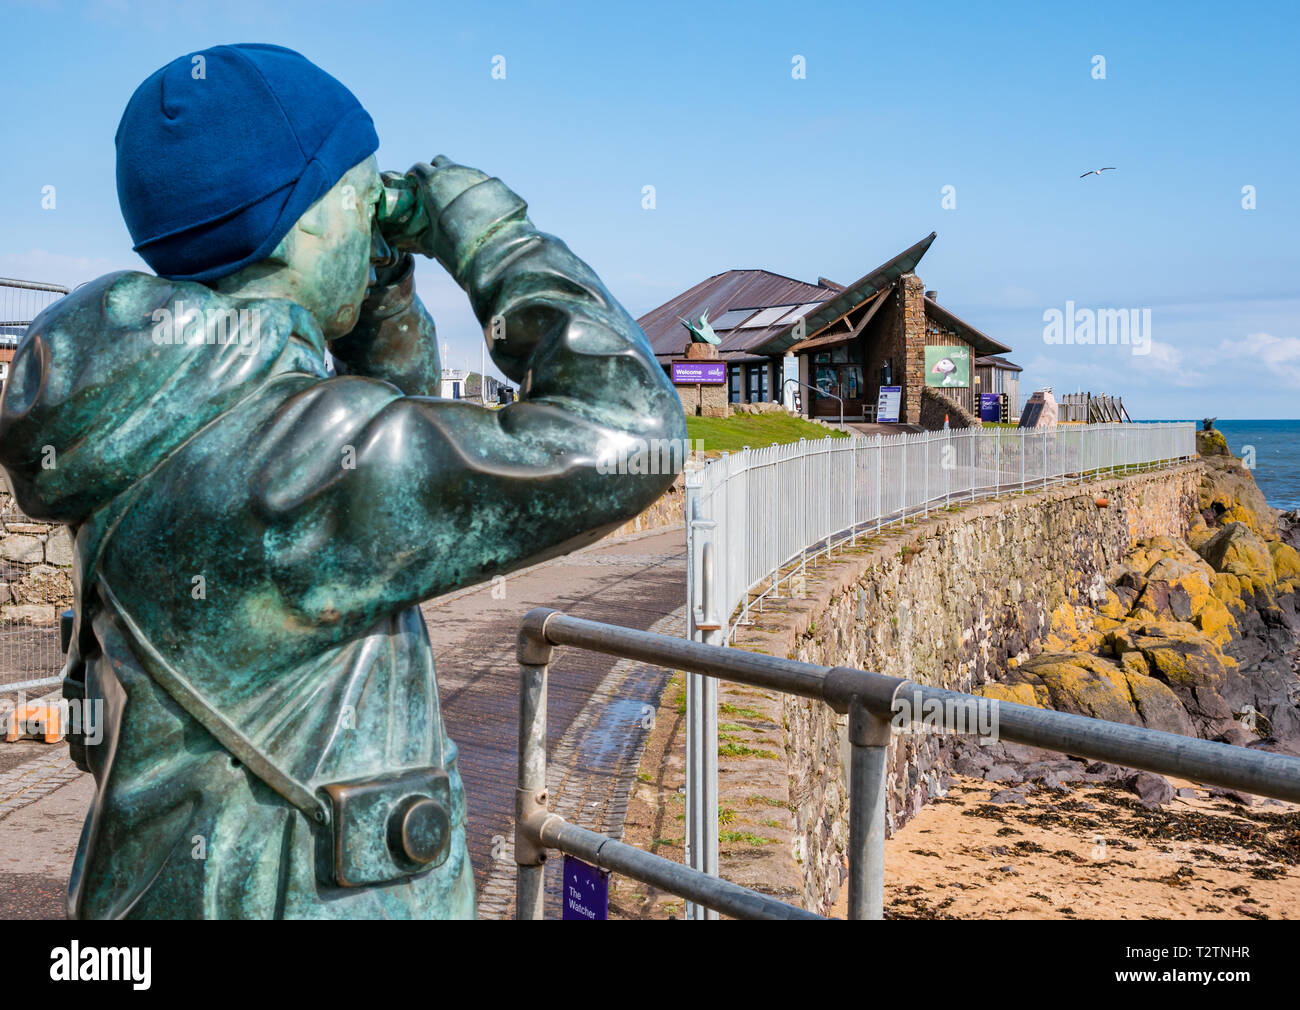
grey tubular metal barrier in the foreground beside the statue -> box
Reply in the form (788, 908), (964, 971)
(515, 607), (1300, 919)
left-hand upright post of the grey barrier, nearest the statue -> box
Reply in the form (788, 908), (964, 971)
(515, 615), (555, 919)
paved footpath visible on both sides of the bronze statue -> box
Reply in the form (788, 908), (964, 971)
(0, 526), (686, 919)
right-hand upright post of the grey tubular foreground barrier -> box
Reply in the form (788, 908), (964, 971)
(849, 698), (889, 919)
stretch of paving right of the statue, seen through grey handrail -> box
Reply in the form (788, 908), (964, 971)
(424, 528), (686, 918)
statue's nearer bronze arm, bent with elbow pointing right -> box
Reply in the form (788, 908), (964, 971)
(246, 166), (685, 620)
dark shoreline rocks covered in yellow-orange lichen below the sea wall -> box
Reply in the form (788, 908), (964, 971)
(953, 432), (1300, 807)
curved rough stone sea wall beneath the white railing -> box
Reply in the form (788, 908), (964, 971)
(735, 464), (1200, 913)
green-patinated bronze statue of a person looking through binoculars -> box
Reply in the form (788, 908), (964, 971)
(0, 47), (685, 918)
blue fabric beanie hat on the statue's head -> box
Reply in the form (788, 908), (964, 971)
(116, 43), (380, 281)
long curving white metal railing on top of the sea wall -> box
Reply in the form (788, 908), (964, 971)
(686, 421), (1196, 641)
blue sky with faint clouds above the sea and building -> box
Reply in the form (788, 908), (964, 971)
(0, 0), (1300, 417)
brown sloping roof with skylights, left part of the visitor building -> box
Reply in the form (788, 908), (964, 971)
(637, 270), (836, 356)
